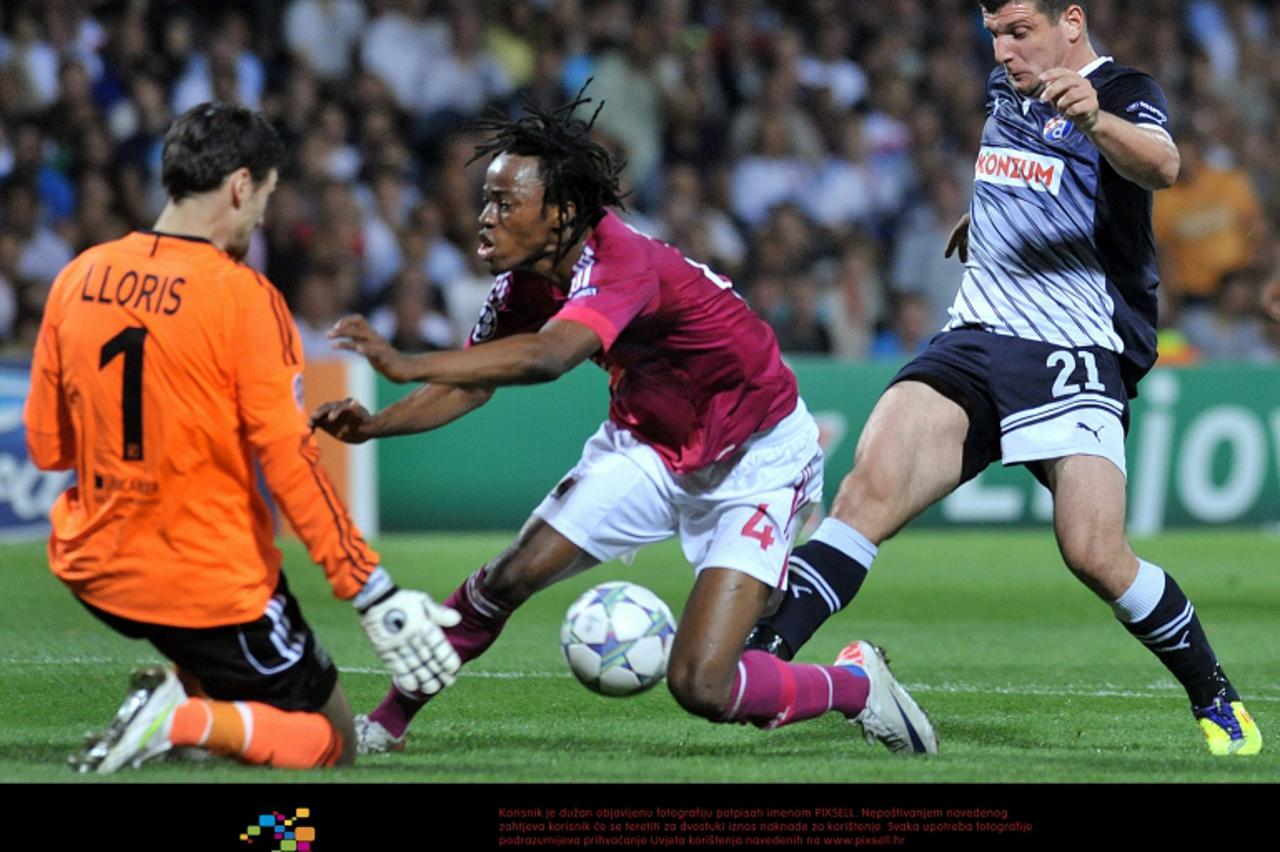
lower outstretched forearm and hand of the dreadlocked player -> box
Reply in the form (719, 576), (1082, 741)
(310, 384), (493, 444)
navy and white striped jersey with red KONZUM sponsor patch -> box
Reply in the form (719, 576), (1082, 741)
(946, 56), (1169, 397)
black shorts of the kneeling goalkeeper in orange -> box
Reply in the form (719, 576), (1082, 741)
(77, 573), (338, 713)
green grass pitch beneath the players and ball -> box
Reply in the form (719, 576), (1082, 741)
(0, 531), (1280, 783)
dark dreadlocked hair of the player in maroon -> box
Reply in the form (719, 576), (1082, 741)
(467, 79), (628, 262)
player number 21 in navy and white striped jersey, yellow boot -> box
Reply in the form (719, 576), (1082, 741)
(749, 0), (1262, 755)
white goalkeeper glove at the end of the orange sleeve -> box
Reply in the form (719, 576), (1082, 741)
(352, 568), (462, 695)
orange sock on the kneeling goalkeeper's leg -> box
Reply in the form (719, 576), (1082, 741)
(169, 698), (343, 769)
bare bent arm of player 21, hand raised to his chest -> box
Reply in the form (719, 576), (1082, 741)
(1041, 68), (1181, 189)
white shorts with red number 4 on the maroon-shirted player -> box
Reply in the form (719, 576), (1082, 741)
(534, 400), (823, 588)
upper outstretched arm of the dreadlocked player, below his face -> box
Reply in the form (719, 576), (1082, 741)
(329, 315), (602, 386)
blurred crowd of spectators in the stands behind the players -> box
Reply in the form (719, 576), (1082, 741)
(0, 0), (1280, 362)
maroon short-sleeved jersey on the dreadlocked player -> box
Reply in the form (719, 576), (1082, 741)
(467, 212), (797, 473)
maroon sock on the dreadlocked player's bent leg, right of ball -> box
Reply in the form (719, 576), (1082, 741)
(723, 650), (870, 729)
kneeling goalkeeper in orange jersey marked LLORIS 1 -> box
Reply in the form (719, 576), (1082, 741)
(24, 104), (458, 773)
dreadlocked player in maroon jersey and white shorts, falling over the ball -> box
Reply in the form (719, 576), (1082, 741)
(312, 94), (937, 751)
